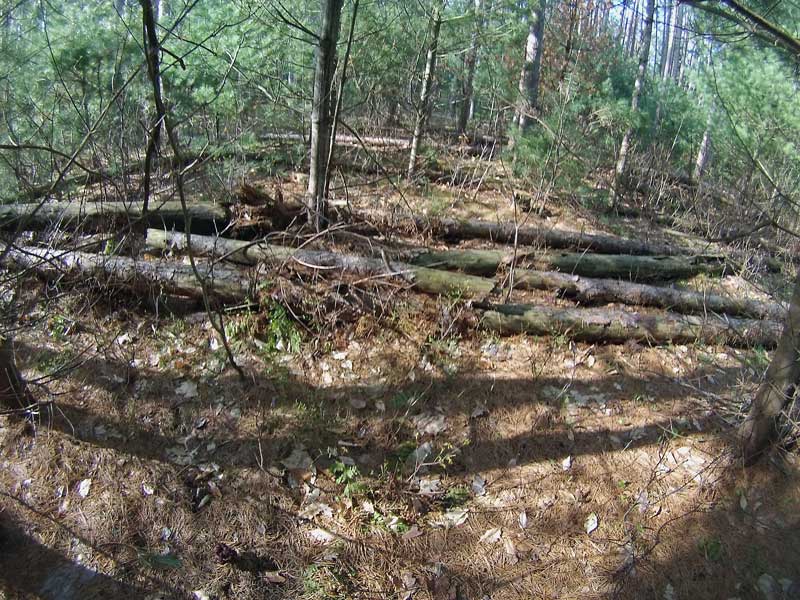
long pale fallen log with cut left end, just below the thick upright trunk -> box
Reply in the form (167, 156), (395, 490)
(147, 229), (495, 297)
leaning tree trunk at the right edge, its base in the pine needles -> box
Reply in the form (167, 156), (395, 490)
(739, 277), (800, 464)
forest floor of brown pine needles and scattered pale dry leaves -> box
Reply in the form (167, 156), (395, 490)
(0, 156), (800, 600)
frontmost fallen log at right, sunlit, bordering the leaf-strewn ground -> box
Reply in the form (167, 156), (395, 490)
(479, 304), (782, 348)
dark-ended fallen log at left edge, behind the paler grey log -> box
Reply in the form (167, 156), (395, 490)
(0, 200), (230, 229)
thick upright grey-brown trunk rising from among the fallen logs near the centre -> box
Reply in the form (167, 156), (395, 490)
(306, 0), (344, 231)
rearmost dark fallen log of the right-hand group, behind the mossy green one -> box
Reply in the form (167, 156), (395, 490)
(340, 211), (692, 256)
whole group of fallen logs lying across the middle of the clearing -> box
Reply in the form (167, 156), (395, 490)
(0, 187), (786, 347)
